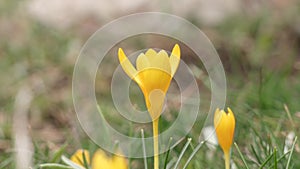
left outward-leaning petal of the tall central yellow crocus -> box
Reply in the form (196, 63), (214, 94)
(118, 48), (137, 79)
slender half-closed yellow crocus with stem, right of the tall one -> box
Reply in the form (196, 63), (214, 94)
(214, 108), (235, 169)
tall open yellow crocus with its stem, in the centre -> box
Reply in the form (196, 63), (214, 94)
(118, 44), (180, 169)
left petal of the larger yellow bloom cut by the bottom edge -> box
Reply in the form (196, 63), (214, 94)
(92, 149), (114, 169)
